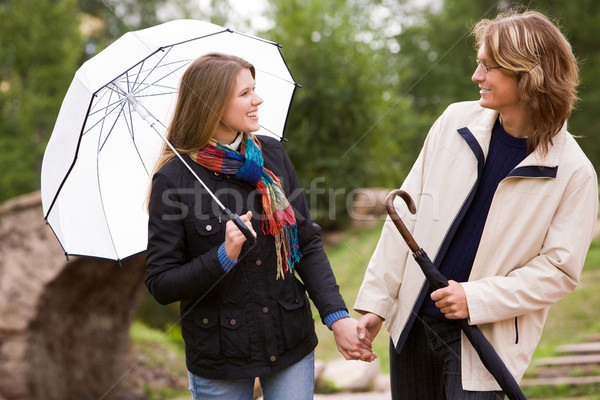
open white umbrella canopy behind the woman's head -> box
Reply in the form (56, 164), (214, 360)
(41, 20), (299, 260)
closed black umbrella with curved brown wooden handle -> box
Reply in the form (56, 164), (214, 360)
(386, 189), (527, 400)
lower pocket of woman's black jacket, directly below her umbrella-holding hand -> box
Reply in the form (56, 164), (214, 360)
(220, 310), (250, 358)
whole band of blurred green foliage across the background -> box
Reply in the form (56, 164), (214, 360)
(0, 0), (600, 229)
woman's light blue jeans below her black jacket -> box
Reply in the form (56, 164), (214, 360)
(188, 352), (315, 400)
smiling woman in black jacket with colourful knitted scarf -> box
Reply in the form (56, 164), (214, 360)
(146, 53), (374, 399)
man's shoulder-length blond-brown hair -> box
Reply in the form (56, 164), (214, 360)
(473, 11), (579, 154)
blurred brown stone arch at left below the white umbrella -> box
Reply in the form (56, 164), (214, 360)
(0, 193), (145, 400)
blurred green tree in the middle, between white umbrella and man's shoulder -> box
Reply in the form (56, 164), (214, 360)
(257, 0), (422, 227)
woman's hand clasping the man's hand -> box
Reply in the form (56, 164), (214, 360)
(331, 318), (377, 362)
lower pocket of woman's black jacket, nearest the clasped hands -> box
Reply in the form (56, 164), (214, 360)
(279, 293), (315, 349)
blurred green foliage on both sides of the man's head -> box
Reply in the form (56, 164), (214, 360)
(397, 0), (600, 171)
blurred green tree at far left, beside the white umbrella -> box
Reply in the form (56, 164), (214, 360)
(0, 0), (82, 200)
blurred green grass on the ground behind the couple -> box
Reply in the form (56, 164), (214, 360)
(131, 223), (600, 400)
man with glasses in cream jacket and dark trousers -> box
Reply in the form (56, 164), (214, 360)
(355, 12), (598, 399)
